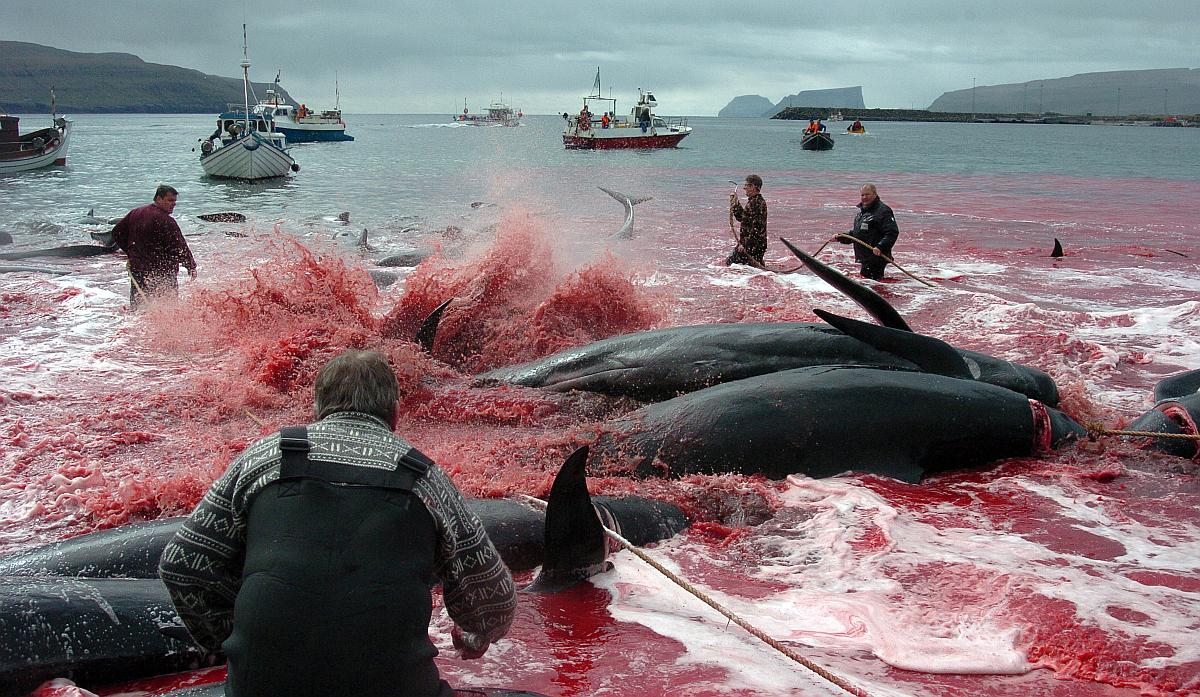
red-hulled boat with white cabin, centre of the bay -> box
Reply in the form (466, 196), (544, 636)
(563, 68), (691, 150)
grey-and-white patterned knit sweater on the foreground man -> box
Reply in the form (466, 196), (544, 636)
(158, 411), (516, 649)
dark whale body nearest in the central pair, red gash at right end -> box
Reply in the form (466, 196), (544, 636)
(592, 366), (1085, 482)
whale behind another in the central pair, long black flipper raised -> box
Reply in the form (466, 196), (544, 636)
(475, 241), (1058, 407)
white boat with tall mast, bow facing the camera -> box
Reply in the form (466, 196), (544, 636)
(200, 24), (300, 181)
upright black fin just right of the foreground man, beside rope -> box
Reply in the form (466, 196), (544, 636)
(524, 445), (610, 593)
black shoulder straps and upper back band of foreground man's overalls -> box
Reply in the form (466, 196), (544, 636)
(280, 426), (433, 492)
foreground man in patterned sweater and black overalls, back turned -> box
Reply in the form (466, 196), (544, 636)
(158, 349), (516, 697)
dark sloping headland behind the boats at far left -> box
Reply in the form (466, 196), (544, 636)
(0, 41), (295, 114)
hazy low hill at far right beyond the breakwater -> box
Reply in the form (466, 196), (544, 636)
(929, 68), (1200, 116)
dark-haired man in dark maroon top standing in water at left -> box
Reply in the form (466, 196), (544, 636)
(113, 185), (196, 308)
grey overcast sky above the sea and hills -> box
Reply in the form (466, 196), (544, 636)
(0, 0), (1200, 115)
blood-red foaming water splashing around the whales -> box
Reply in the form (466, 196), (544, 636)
(0, 172), (1200, 696)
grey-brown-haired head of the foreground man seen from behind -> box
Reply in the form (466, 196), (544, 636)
(313, 349), (400, 425)
